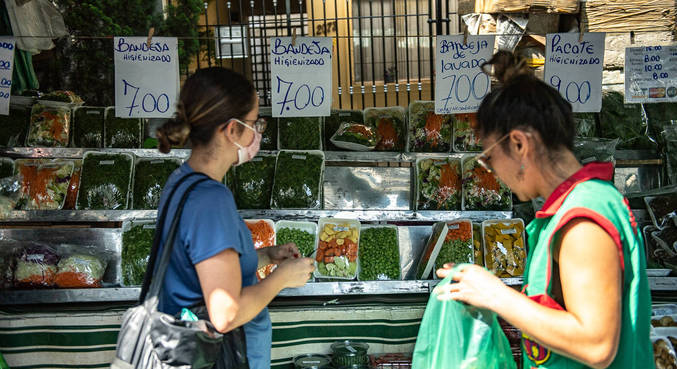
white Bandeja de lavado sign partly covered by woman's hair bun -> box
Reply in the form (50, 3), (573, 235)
(435, 35), (495, 114)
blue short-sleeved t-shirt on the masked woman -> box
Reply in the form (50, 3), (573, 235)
(158, 163), (272, 369)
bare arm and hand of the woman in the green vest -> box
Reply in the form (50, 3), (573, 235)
(440, 219), (622, 368)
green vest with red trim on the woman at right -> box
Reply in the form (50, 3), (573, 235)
(522, 179), (654, 369)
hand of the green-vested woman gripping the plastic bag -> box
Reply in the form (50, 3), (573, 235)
(434, 264), (509, 310)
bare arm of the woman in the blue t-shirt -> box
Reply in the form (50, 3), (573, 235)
(195, 249), (314, 333)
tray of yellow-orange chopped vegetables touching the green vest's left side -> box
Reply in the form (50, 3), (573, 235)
(482, 219), (527, 278)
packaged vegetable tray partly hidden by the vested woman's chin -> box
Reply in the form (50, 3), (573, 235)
(463, 157), (512, 211)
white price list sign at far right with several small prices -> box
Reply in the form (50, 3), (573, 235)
(625, 46), (677, 103)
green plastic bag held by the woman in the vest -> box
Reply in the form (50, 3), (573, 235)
(412, 264), (516, 369)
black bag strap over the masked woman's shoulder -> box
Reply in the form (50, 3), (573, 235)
(139, 172), (209, 303)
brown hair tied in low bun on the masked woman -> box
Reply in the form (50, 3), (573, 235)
(157, 67), (255, 153)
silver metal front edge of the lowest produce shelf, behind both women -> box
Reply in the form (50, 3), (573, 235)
(0, 277), (677, 306)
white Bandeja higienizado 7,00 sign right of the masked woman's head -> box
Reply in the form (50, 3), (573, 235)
(270, 37), (332, 117)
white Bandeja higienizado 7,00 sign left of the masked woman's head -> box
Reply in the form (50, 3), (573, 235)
(113, 37), (179, 118)
